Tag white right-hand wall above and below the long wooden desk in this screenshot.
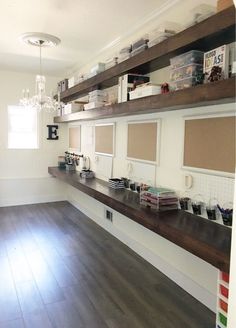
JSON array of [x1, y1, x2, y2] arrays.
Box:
[[68, 104, 234, 310]]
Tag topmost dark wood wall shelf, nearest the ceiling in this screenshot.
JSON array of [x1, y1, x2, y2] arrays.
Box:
[[61, 6, 235, 102]]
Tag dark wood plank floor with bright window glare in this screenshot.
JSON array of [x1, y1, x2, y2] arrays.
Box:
[[0, 202, 215, 328]]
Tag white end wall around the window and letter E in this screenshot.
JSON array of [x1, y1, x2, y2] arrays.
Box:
[[0, 71, 67, 206]]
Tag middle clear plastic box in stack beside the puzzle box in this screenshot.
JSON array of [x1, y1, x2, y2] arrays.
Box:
[[170, 64, 203, 82]]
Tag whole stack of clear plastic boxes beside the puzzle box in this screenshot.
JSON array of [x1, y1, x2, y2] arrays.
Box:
[[170, 50, 204, 89]]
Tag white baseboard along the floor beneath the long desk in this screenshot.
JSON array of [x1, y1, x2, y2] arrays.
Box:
[[68, 195, 216, 312]]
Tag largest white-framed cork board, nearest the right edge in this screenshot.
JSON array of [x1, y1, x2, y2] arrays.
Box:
[[183, 116, 235, 173]]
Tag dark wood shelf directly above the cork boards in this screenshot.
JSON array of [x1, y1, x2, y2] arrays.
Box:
[[54, 78, 235, 123]]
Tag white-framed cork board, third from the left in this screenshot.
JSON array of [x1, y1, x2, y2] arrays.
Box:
[[127, 122, 157, 162]]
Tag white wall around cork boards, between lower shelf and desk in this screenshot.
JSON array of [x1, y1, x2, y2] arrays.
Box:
[[73, 104, 234, 215]]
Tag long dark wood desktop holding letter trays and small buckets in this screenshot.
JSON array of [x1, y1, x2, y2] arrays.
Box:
[[48, 167, 231, 272]]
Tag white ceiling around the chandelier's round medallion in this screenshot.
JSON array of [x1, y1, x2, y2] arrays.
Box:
[[0, 0, 170, 76]]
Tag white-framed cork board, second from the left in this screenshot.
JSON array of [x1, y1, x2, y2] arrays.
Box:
[[95, 124, 114, 155]]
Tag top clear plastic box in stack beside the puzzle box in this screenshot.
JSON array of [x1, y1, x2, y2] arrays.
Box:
[[170, 50, 204, 69]]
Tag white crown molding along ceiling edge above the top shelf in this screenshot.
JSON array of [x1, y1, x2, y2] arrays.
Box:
[[70, 0, 181, 73]]
